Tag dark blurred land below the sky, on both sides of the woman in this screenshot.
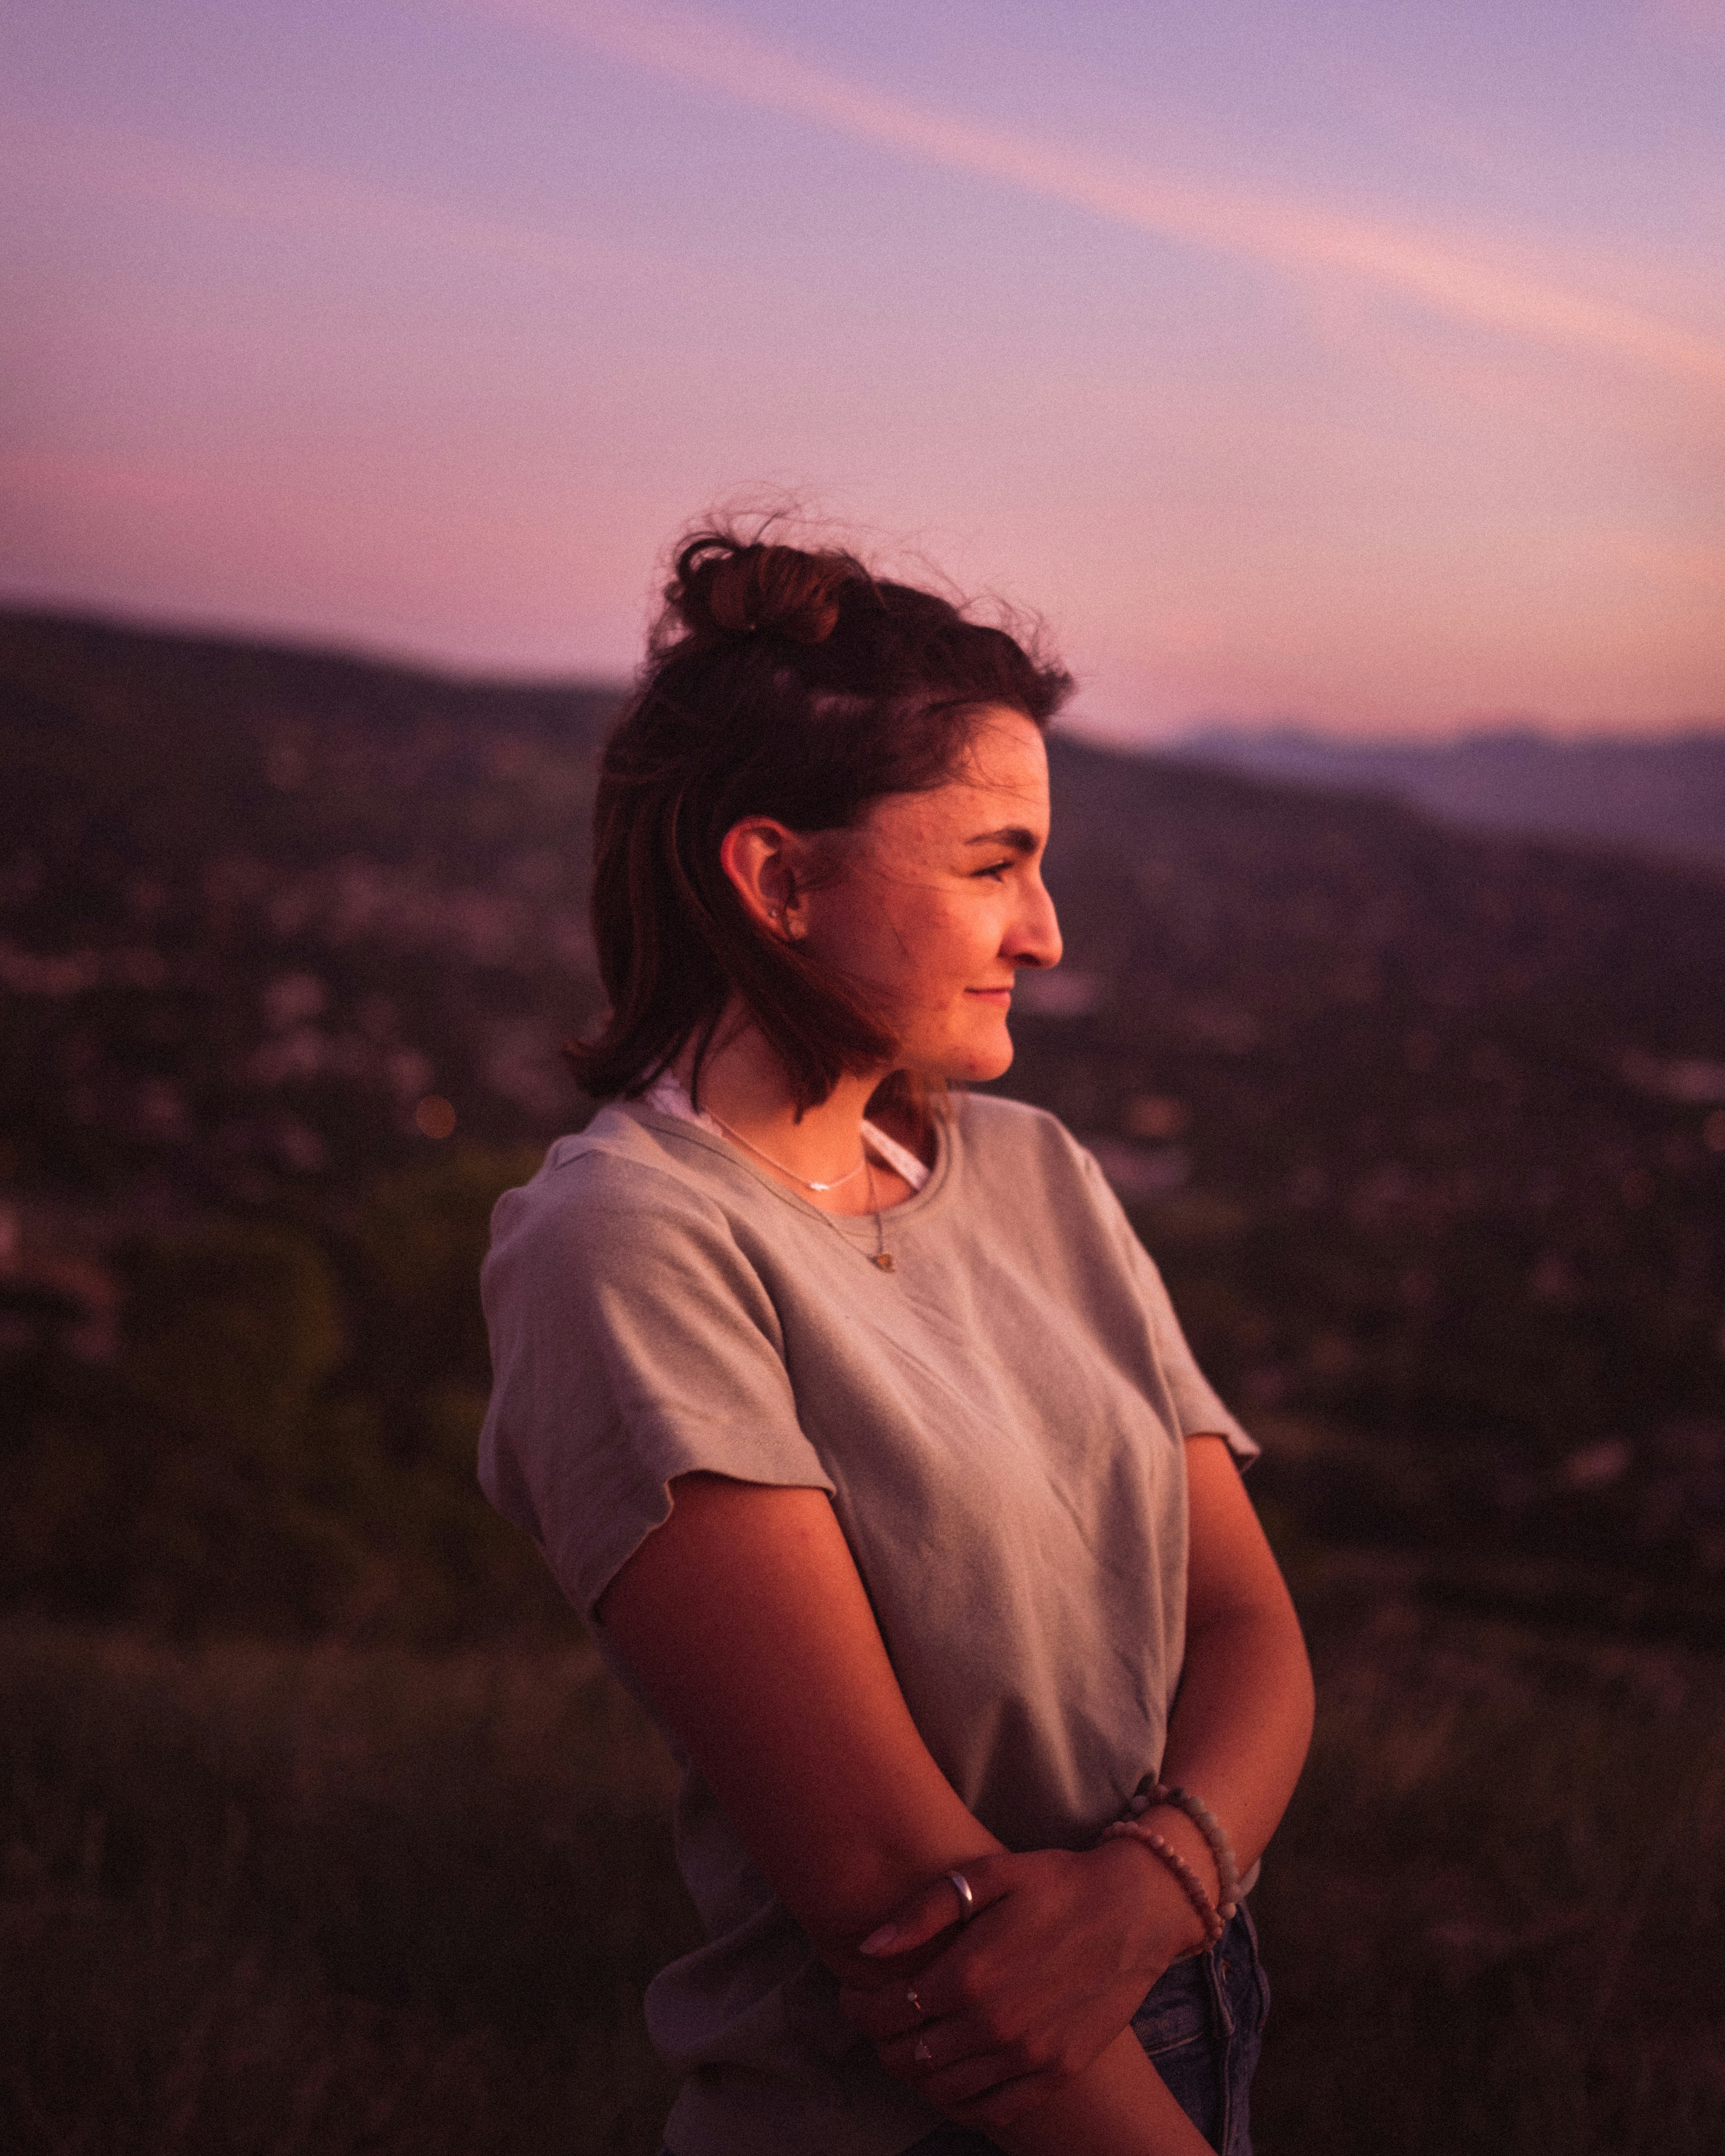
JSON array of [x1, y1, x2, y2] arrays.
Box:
[[0, 612, 1725, 2156]]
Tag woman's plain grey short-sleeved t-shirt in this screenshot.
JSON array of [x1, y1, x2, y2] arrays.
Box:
[[479, 1095, 1257, 2156]]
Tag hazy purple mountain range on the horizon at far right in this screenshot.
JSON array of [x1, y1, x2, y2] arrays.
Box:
[[1177, 720, 1725, 862]]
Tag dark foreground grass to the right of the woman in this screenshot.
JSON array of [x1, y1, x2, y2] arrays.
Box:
[[1255, 1574, 1725, 2156]]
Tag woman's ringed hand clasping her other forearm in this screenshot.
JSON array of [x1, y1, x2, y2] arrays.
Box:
[[839, 1841, 1203, 2126]]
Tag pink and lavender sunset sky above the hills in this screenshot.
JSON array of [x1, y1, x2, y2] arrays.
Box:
[[0, 0, 1725, 740]]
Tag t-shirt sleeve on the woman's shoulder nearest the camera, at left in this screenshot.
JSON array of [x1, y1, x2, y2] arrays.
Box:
[[479, 1147, 832, 1619]]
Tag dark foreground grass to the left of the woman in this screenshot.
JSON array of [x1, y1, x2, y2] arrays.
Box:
[[0, 1628, 694, 2156]]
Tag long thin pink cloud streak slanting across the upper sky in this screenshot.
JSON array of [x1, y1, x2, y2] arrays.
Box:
[[472, 0, 1725, 388]]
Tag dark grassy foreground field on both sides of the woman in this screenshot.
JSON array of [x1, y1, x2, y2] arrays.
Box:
[[0, 1567, 1725, 2156]]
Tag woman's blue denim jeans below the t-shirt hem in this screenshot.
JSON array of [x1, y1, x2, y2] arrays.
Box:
[[664, 1901, 1270, 2156]]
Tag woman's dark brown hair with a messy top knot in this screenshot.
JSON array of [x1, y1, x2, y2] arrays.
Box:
[[565, 530, 1071, 1112]]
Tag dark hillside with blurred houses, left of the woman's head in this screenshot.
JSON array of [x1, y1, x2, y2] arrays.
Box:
[[0, 614, 619, 1203]]
